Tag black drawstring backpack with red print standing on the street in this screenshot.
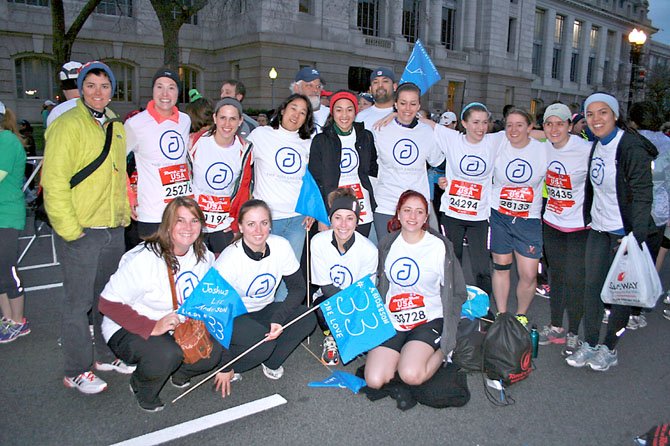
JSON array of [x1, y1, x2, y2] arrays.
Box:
[[482, 313, 533, 387]]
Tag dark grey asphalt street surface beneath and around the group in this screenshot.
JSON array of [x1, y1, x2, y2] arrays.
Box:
[[0, 217, 670, 445]]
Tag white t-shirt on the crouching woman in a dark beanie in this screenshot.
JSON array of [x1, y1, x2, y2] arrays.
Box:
[[310, 229, 379, 289]]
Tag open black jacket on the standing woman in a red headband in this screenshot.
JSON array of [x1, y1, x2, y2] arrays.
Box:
[[308, 122, 377, 212]]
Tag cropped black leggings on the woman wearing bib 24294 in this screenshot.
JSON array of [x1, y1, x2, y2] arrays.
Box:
[[440, 212, 493, 296]]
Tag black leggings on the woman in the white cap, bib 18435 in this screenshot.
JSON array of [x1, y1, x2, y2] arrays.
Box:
[[542, 223, 589, 334]]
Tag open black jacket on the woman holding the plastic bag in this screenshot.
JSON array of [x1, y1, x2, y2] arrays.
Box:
[[584, 131, 658, 243]]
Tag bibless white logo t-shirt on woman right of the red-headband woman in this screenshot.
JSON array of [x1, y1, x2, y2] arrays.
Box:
[[373, 120, 444, 215]]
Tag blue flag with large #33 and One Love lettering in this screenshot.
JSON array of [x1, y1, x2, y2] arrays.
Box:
[[319, 276, 396, 363]]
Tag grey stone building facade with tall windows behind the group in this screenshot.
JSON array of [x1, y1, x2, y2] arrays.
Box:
[[0, 0, 667, 120]]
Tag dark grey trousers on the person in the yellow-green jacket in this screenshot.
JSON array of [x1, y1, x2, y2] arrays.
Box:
[[54, 228, 125, 377]]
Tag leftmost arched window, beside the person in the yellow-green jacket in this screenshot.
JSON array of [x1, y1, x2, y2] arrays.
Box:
[[14, 56, 58, 100]]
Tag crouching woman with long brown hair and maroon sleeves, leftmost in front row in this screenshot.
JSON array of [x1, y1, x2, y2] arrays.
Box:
[[100, 197, 233, 412]]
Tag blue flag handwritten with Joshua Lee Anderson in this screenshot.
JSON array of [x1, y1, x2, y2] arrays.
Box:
[[177, 268, 247, 348]]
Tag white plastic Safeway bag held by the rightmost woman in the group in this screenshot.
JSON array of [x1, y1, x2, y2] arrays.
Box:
[[600, 232, 663, 308]]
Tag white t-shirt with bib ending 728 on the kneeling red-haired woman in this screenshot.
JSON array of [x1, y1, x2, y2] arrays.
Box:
[[384, 232, 446, 331]]
